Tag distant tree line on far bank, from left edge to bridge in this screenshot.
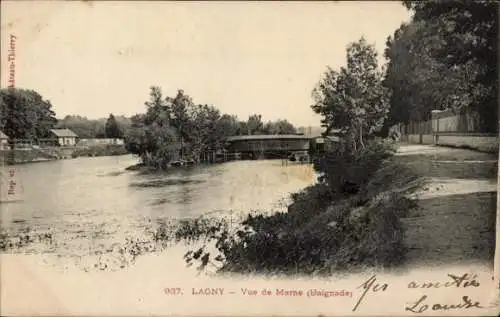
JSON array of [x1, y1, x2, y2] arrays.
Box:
[[0, 87, 296, 167]]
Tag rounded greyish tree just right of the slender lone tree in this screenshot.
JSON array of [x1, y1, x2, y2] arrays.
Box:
[[384, 21, 476, 124]]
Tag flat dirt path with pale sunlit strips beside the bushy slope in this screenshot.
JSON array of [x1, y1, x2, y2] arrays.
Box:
[[398, 145, 498, 267]]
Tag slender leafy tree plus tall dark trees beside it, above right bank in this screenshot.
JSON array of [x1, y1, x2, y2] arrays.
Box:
[[311, 0, 498, 150]]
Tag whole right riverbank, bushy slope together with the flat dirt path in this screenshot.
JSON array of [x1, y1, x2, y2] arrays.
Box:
[[170, 141, 498, 275]]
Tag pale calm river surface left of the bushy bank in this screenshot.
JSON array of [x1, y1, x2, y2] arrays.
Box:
[[0, 156, 314, 270]]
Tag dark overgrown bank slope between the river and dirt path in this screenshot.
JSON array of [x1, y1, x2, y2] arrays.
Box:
[[172, 141, 423, 274]]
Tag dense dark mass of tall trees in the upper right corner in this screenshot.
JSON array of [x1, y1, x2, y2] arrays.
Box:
[[385, 0, 498, 132]]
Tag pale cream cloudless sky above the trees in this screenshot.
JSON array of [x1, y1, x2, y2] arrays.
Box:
[[1, 1, 410, 126]]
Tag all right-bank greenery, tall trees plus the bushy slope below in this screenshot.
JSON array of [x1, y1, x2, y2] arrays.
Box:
[[164, 0, 498, 273]]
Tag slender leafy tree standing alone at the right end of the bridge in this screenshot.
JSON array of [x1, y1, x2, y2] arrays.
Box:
[[311, 38, 389, 150]]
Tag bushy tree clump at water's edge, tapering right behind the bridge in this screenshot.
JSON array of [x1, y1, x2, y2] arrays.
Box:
[[125, 86, 296, 168]]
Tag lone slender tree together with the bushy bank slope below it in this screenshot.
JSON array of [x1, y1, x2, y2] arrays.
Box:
[[170, 38, 423, 275]]
